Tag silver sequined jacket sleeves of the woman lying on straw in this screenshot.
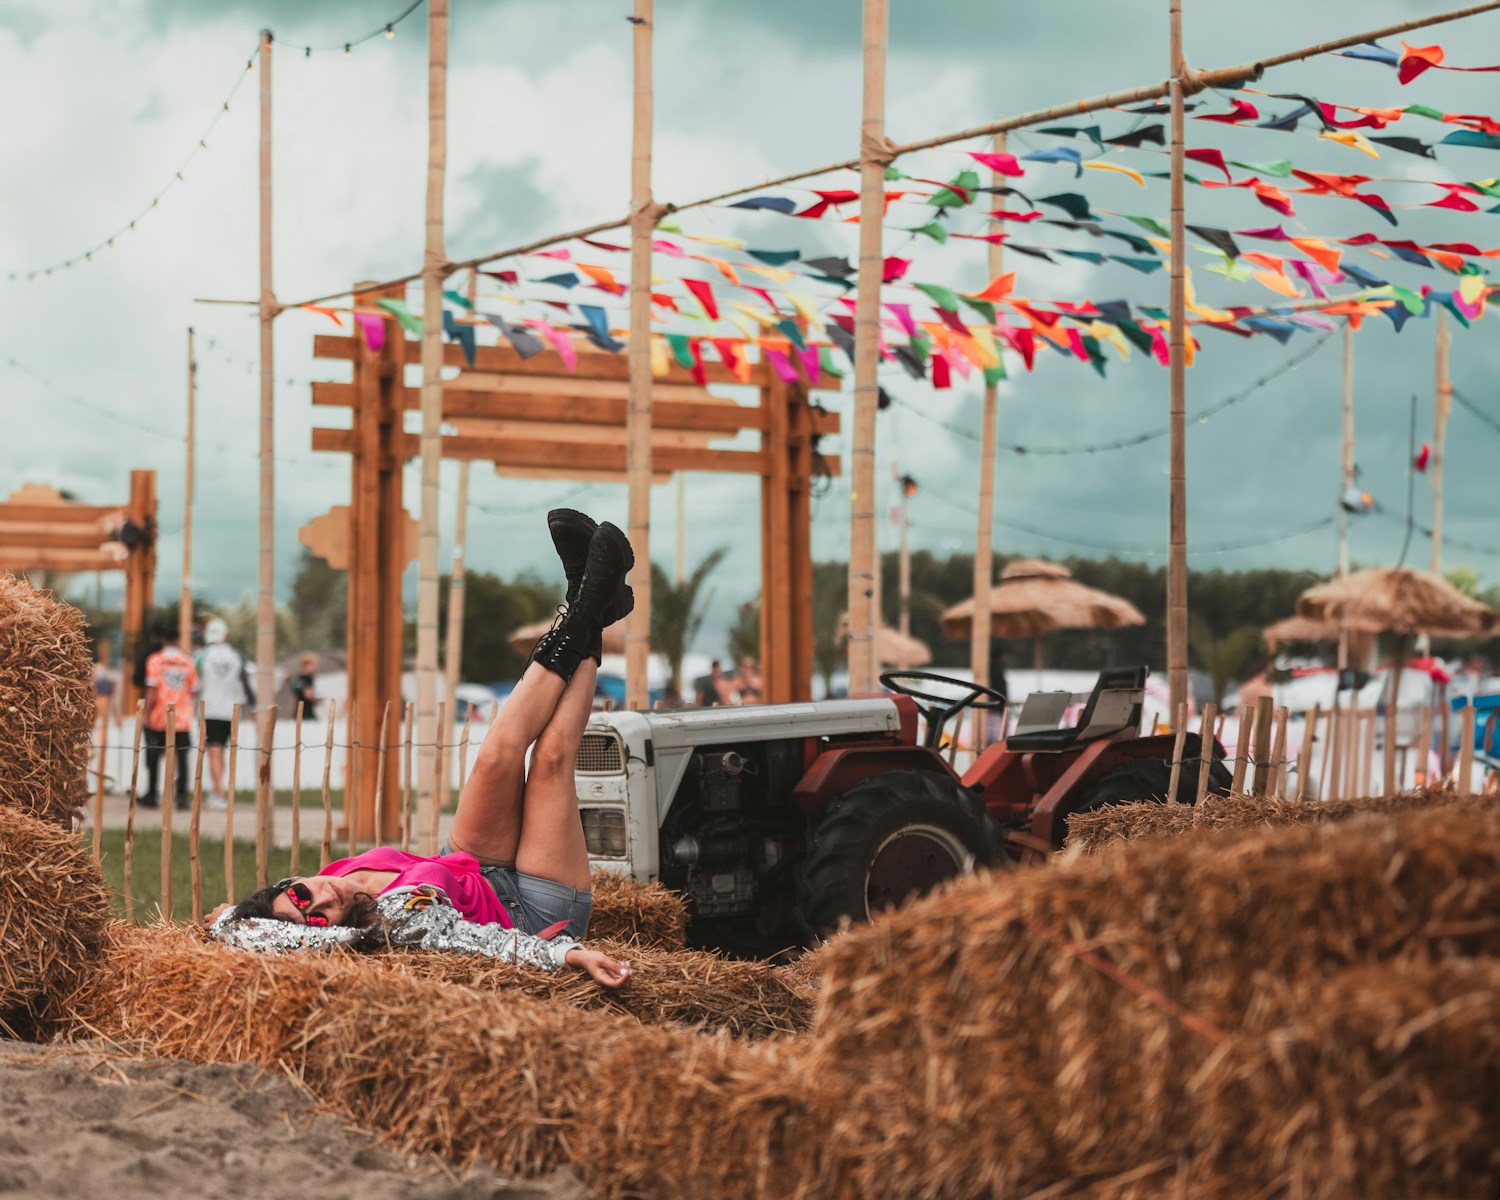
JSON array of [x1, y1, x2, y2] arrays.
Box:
[[210, 885, 578, 971]]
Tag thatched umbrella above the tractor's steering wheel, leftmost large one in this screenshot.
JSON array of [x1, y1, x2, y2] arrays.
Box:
[[942, 558, 1146, 681]]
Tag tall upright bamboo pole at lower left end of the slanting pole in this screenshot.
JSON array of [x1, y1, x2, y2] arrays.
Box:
[[255, 29, 278, 732]]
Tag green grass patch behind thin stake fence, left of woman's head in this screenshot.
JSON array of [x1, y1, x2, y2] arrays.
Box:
[[95, 828, 330, 926]]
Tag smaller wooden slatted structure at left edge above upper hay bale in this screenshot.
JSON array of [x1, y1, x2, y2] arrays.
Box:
[[0, 471, 156, 711]]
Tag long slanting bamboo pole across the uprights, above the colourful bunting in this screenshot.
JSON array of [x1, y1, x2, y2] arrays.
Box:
[[273, 0, 1500, 312]]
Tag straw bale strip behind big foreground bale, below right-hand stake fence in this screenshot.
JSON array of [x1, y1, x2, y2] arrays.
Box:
[[1068, 788, 1497, 854]]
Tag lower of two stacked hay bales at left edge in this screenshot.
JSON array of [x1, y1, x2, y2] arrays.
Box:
[[0, 807, 110, 1037]]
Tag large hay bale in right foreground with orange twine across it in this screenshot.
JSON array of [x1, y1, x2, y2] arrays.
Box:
[[810, 812, 1500, 1196]]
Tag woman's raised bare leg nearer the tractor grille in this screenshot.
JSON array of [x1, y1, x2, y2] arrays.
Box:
[[516, 660, 597, 891]]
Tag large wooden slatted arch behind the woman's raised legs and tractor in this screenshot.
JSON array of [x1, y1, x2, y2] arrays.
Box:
[[300, 291, 839, 840]]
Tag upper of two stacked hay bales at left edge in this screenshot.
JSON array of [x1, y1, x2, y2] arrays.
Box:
[[0, 573, 95, 828]]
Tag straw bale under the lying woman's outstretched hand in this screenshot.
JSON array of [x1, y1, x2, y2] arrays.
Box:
[[381, 938, 813, 1038]]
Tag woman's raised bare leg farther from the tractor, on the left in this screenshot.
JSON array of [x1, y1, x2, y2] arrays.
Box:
[[449, 660, 573, 866]]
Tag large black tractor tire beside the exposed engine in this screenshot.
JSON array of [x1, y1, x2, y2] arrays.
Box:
[[797, 771, 1010, 941]]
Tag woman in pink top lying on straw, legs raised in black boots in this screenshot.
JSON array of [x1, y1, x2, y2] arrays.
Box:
[[209, 509, 635, 987]]
